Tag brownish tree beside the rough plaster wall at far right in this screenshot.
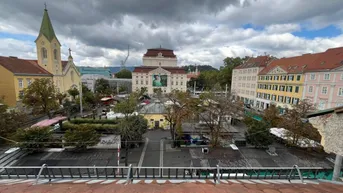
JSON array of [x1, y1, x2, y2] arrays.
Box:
[[279, 100, 321, 145]]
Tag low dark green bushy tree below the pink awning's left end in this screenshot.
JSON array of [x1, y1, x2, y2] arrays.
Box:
[[15, 127, 52, 151]]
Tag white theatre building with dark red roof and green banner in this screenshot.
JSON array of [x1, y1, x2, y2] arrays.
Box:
[[132, 48, 187, 94]]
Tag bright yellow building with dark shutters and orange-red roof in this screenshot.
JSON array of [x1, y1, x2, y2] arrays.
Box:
[[256, 54, 316, 109]]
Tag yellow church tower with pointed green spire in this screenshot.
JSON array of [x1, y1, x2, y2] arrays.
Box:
[[35, 7, 62, 76]]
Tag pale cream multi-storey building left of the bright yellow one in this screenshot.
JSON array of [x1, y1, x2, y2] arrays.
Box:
[[231, 56, 271, 106]]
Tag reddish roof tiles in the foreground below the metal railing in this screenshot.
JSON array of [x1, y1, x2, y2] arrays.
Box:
[[0, 180, 343, 193]]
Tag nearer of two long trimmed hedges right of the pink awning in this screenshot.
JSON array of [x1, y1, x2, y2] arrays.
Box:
[[62, 122, 119, 134]]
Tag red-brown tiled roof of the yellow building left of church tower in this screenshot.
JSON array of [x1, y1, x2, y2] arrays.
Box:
[[0, 56, 52, 76]]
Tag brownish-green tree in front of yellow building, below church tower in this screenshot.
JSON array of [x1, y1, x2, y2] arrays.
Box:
[[22, 78, 58, 118]]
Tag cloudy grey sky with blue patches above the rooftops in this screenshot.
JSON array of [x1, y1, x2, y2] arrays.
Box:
[[0, 0, 343, 67]]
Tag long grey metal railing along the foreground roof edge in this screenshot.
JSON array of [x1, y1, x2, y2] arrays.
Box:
[[0, 164, 333, 184]]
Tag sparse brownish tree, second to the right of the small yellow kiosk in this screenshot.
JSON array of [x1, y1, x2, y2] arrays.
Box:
[[193, 92, 244, 147]]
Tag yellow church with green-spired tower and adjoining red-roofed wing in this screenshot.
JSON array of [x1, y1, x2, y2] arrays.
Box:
[[0, 9, 81, 107]]
